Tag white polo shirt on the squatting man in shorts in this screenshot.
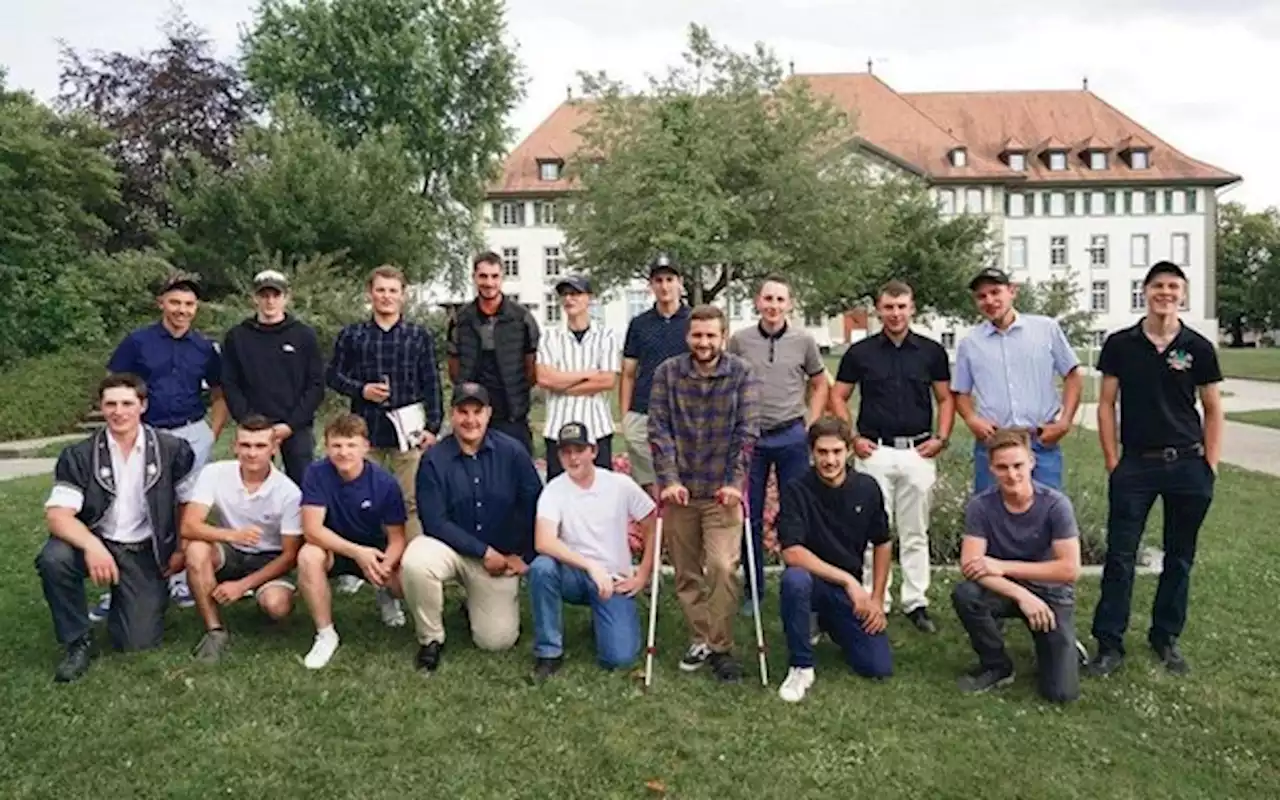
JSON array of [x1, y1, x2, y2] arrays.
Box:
[[191, 461, 302, 553]]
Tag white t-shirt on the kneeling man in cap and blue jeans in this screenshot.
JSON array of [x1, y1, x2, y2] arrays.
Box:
[[538, 470, 654, 575]]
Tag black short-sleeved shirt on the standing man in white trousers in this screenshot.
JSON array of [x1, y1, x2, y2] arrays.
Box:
[[836, 330, 951, 439]]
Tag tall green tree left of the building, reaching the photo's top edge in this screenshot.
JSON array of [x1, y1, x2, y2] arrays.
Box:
[[243, 0, 522, 280]]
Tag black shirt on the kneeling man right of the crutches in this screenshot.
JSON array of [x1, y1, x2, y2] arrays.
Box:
[[778, 467, 888, 580]]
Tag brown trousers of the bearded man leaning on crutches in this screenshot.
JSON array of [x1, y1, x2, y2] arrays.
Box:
[[663, 500, 742, 653]]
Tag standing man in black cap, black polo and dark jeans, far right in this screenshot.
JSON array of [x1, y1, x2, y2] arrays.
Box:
[[1089, 261, 1224, 677]]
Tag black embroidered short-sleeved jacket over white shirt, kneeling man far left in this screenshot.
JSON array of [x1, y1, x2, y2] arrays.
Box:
[[54, 425, 196, 570]]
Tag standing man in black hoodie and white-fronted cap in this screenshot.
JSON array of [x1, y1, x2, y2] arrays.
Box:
[[223, 270, 324, 486]]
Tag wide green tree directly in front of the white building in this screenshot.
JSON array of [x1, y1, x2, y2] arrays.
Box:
[[561, 26, 987, 312]]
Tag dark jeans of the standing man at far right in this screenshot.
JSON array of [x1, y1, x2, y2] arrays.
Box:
[[1093, 454, 1215, 653]]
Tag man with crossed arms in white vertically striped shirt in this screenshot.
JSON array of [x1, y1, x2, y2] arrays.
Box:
[[538, 275, 622, 480]]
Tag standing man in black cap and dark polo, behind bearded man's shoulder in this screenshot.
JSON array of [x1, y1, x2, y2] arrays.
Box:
[[618, 255, 690, 494]]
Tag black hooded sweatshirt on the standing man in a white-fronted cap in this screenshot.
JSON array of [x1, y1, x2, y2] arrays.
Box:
[[223, 315, 324, 430]]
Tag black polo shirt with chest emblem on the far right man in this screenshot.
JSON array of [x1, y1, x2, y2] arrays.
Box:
[[1098, 321, 1222, 451]]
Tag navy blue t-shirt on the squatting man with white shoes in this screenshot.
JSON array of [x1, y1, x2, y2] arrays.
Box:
[[302, 458, 408, 549]]
